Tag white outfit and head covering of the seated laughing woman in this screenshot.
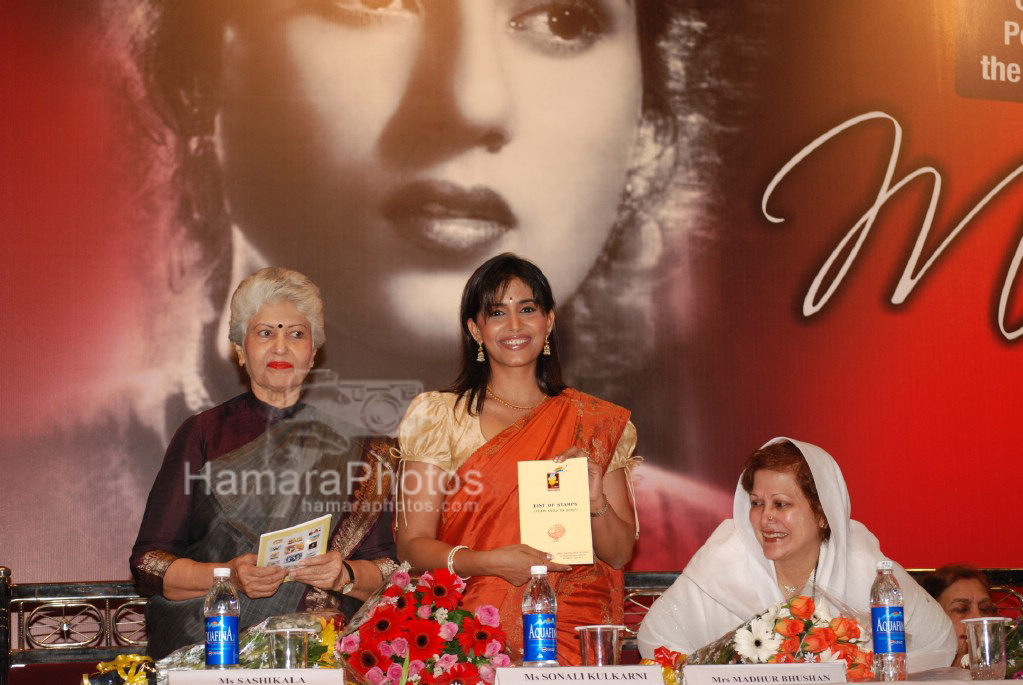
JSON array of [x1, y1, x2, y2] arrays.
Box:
[[638, 438, 957, 673]]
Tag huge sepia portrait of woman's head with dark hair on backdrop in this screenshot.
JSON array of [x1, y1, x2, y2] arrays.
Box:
[[138, 0, 724, 415]]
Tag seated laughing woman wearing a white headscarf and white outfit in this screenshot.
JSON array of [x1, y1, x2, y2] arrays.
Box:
[[638, 438, 955, 673]]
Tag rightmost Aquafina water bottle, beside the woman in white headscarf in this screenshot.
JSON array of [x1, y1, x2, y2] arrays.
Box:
[[871, 559, 905, 682]]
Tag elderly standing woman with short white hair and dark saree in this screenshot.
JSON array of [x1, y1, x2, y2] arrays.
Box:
[[131, 268, 395, 658]]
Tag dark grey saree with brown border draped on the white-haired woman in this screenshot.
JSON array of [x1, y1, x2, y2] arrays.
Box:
[[146, 407, 395, 658]]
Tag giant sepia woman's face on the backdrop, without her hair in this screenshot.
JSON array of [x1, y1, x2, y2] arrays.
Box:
[[218, 0, 641, 352]]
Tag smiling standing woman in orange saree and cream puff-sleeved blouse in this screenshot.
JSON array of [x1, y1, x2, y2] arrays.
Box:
[[396, 254, 638, 664]]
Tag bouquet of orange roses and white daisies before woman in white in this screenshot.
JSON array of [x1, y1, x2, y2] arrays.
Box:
[[655, 596, 874, 682]]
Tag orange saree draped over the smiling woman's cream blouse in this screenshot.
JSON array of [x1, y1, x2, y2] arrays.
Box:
[[438, 389, 629, 665]]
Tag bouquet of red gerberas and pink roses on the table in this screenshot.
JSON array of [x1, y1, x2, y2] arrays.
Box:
[[338, 564, 512, 685]]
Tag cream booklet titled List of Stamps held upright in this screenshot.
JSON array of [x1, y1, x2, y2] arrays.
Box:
[[519, 457, 593, 564]]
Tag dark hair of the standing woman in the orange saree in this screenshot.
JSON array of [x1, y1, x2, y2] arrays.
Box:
[[447, 253, 566, 414]]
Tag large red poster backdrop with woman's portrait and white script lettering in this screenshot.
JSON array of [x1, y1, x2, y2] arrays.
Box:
[[0, 0, 1023, 582]]
